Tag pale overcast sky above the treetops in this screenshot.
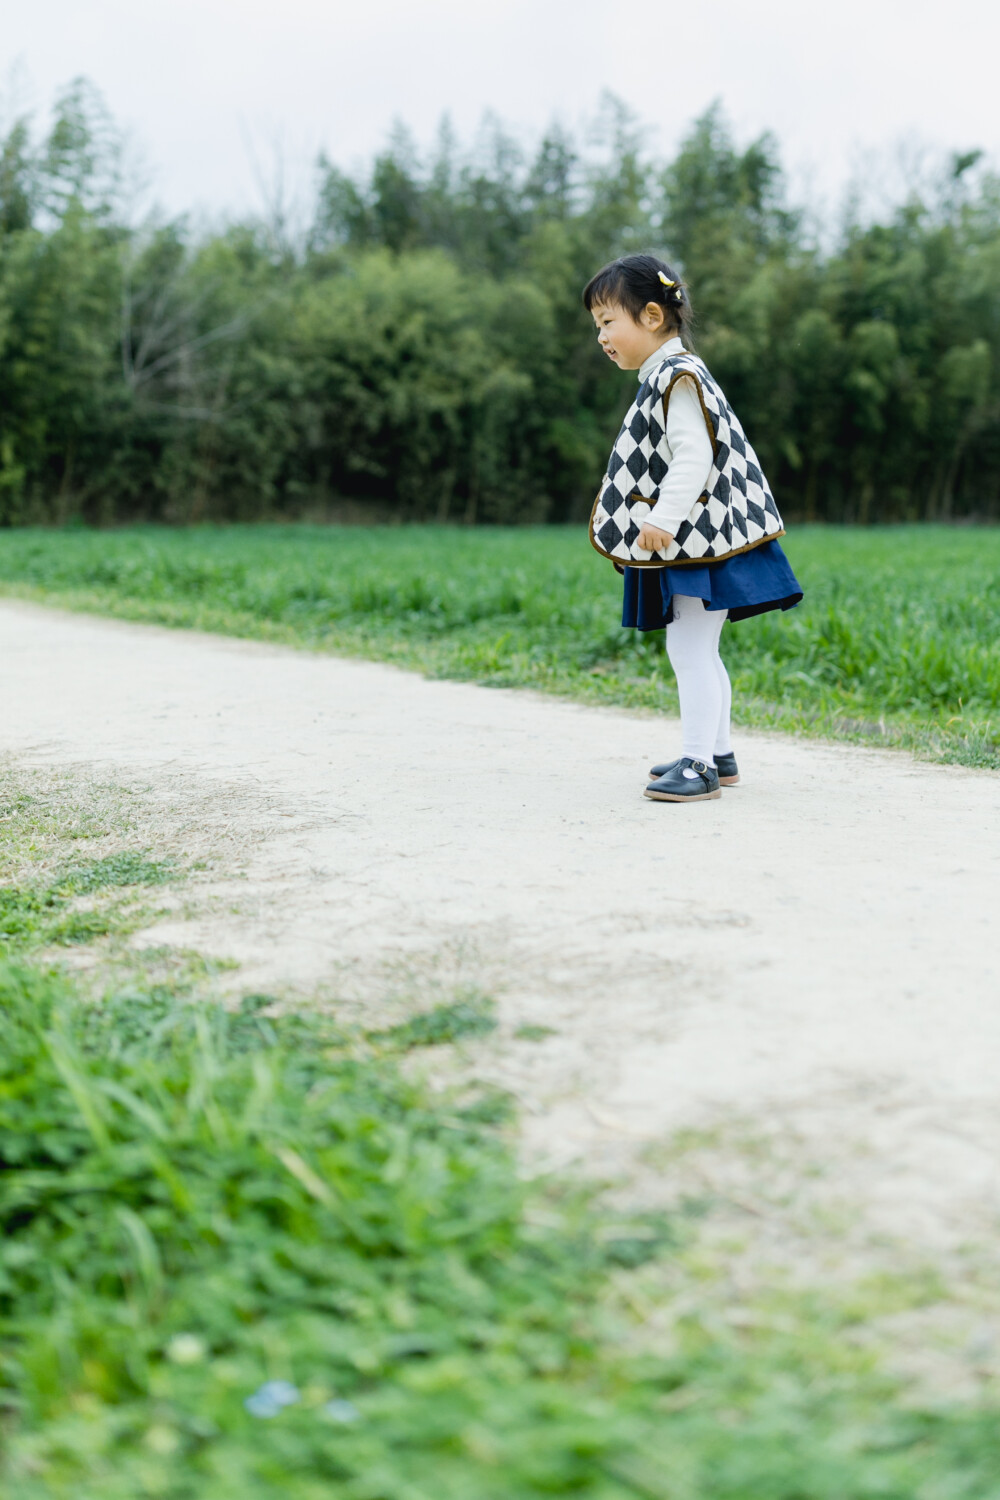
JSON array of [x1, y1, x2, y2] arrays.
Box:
[[0, 0, 1000, 225]]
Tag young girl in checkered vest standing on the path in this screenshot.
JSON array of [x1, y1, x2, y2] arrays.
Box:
[[583, 255, 802, 803]]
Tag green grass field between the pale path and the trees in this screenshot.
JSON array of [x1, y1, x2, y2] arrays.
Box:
[[0, 525, 1000, 767]]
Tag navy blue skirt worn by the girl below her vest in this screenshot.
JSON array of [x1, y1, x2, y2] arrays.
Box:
[[622, 542, 802, 630]]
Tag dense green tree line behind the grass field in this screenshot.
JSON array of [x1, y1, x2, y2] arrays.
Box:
[[0, 81, 1000, 525]]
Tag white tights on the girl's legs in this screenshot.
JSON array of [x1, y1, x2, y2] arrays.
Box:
[[667, 594, 733, 765]]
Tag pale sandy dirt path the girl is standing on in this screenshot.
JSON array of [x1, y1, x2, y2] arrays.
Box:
[[0, 600, 1000, 1266]]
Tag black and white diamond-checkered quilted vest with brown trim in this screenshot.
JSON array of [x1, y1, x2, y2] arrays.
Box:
[[591, 353, 784, 567]]
